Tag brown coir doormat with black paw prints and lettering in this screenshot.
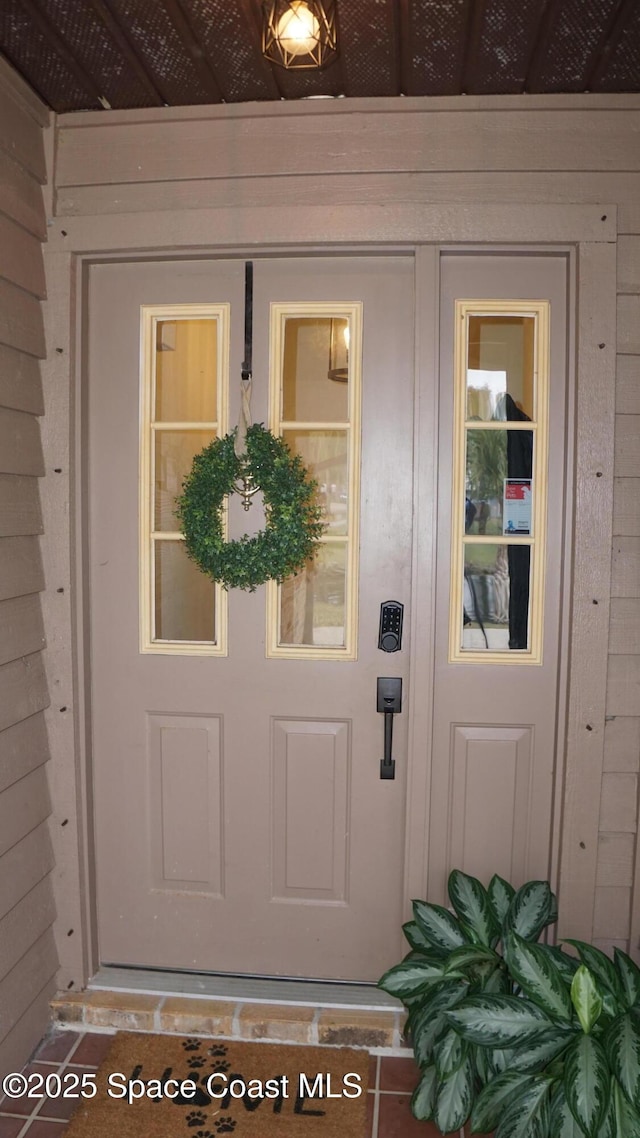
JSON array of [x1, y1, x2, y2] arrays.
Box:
[[64, 1032, 369, 1138]]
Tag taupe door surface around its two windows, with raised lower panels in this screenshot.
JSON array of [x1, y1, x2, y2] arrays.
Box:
[[89, 257, 413, 980]]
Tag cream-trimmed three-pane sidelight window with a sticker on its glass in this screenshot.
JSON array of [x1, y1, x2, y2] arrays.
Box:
[[450, 300, 549, 663]]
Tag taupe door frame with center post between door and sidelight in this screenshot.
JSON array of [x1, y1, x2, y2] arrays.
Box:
[[42, 203, 616, 990]]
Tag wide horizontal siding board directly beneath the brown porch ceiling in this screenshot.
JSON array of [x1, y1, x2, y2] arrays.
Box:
[[56, 105, 640, 187]]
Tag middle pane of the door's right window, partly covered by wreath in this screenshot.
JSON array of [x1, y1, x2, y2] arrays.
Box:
[[284, 430, 348, 535]]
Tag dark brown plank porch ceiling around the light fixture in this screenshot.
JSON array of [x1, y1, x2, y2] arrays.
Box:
[[0, 0, 640, 112]]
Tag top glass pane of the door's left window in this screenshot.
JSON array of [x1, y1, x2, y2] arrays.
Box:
[[155, 319, 218, 422]]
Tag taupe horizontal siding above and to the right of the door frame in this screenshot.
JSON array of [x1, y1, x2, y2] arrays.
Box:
[[48, 96, 640, 975]]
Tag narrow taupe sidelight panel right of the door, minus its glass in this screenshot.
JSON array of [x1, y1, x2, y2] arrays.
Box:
[[428, 254, 567, 900]]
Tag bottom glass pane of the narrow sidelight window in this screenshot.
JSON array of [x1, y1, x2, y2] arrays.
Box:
[[461, 544, 531, 652]]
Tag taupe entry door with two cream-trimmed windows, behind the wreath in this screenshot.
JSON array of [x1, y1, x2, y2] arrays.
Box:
[[88, 256, 413, 980]]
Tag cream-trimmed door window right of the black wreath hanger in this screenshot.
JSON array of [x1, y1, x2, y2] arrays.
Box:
[[268, 302, 362, 660]]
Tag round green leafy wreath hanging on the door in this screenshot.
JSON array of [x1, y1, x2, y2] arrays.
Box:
[[175, 423, 323, 593]]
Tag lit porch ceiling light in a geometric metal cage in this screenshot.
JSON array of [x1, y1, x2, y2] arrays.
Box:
[[262, 0, 337, 71]]
